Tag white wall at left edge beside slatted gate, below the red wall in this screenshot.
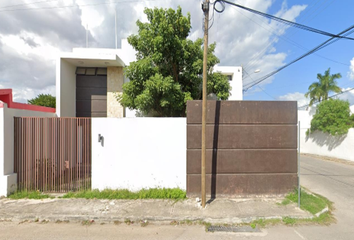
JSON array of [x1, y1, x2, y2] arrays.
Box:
[[0, 103, 56, 196]]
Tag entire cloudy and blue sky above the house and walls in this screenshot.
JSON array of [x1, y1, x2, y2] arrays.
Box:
[[0, 0, 354, 106]]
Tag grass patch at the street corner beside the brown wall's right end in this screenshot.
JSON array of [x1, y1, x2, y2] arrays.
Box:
[[282, 189, 332, 214]]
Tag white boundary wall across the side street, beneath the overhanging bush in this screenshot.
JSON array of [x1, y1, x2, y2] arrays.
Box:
[[298, 108, 354, 161]]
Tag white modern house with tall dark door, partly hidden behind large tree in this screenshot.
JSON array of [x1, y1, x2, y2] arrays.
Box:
[[56, 39, 243, 118]]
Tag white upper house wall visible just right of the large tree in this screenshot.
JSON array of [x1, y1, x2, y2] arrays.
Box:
[[214, 66, 243, 100]]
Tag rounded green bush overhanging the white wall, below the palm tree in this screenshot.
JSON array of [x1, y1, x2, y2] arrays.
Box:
[[310, 99, 354, 136]]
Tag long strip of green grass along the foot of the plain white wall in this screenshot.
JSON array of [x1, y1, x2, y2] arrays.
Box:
[[63, 188, 186, 200]]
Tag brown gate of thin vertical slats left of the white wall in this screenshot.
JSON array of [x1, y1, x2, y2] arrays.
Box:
[[14, 117, 91, 192]]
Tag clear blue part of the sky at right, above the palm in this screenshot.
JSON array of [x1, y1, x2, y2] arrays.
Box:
[[244, 0, 354, 104]]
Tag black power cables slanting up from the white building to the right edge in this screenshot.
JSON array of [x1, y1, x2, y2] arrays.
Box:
[[244, 25, 354, 91]]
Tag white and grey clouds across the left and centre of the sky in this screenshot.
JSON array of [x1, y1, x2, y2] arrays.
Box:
[[0, 0, 306, 100]]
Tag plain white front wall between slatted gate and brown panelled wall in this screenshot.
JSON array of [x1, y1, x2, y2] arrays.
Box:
[[92, 118, 186, 191]]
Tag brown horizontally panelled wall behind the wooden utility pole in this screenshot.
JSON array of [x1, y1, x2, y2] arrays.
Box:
[[187, 101, 297, 197]]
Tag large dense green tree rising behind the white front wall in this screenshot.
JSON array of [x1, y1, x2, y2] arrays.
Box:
[[117, 7, 231, 117]]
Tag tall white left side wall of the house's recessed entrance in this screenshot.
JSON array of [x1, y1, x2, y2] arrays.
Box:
[[56, 58, 76, 117]]
